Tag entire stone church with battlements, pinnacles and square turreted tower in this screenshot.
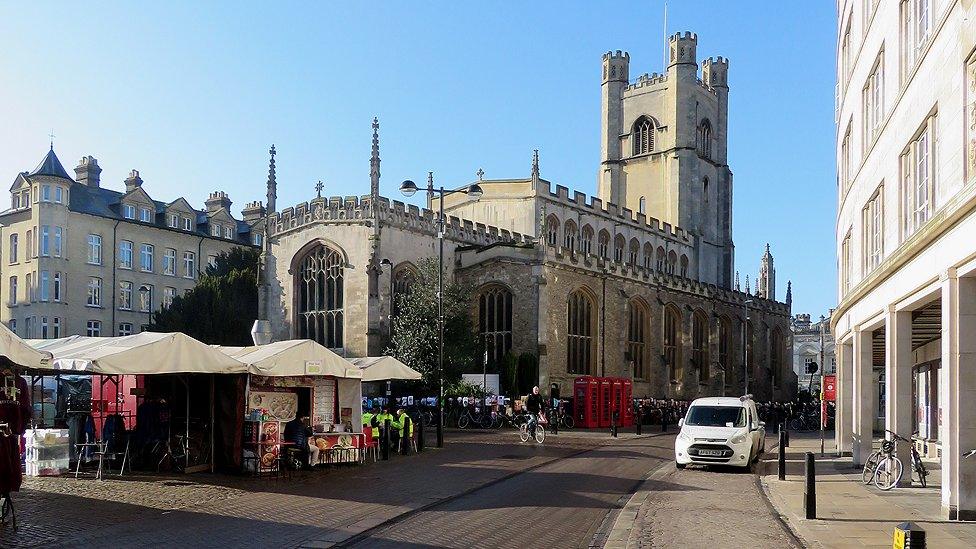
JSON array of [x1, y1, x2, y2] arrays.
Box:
[[261, 33, 796, 399]]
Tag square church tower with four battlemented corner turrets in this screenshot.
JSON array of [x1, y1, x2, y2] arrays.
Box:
[[597, 32, 735, 288]]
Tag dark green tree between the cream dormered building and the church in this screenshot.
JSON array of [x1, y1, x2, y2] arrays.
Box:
[[150, 247, 261, 345]]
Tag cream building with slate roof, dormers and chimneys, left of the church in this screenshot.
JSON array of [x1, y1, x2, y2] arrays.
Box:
[[0, 145, 265, 338]]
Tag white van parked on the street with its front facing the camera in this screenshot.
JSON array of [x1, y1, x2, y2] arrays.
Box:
[[674, 395, 766, 469]]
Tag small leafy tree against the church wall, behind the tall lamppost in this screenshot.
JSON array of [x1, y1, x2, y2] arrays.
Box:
[[387, 258, 481, 388]]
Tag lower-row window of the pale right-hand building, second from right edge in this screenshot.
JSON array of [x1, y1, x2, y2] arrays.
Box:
[[901, 116, 935, 239]]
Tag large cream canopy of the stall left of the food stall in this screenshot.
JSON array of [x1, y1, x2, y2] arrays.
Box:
[[27, 332, 247, 375]]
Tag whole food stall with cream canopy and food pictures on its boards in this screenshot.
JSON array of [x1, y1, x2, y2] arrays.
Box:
[[217, 339, 363, 473]]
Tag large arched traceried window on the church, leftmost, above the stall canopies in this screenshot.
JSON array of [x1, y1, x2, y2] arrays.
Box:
[[296, 245, 343, 349]]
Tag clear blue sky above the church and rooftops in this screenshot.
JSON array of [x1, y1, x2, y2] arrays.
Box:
[[0, 0, 836, 316]]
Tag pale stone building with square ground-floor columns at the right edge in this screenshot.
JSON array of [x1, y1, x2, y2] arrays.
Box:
[[831, 0, 976, 520]]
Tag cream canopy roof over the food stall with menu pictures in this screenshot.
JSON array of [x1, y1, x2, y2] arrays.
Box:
[[215, 339, 362, 379]]
